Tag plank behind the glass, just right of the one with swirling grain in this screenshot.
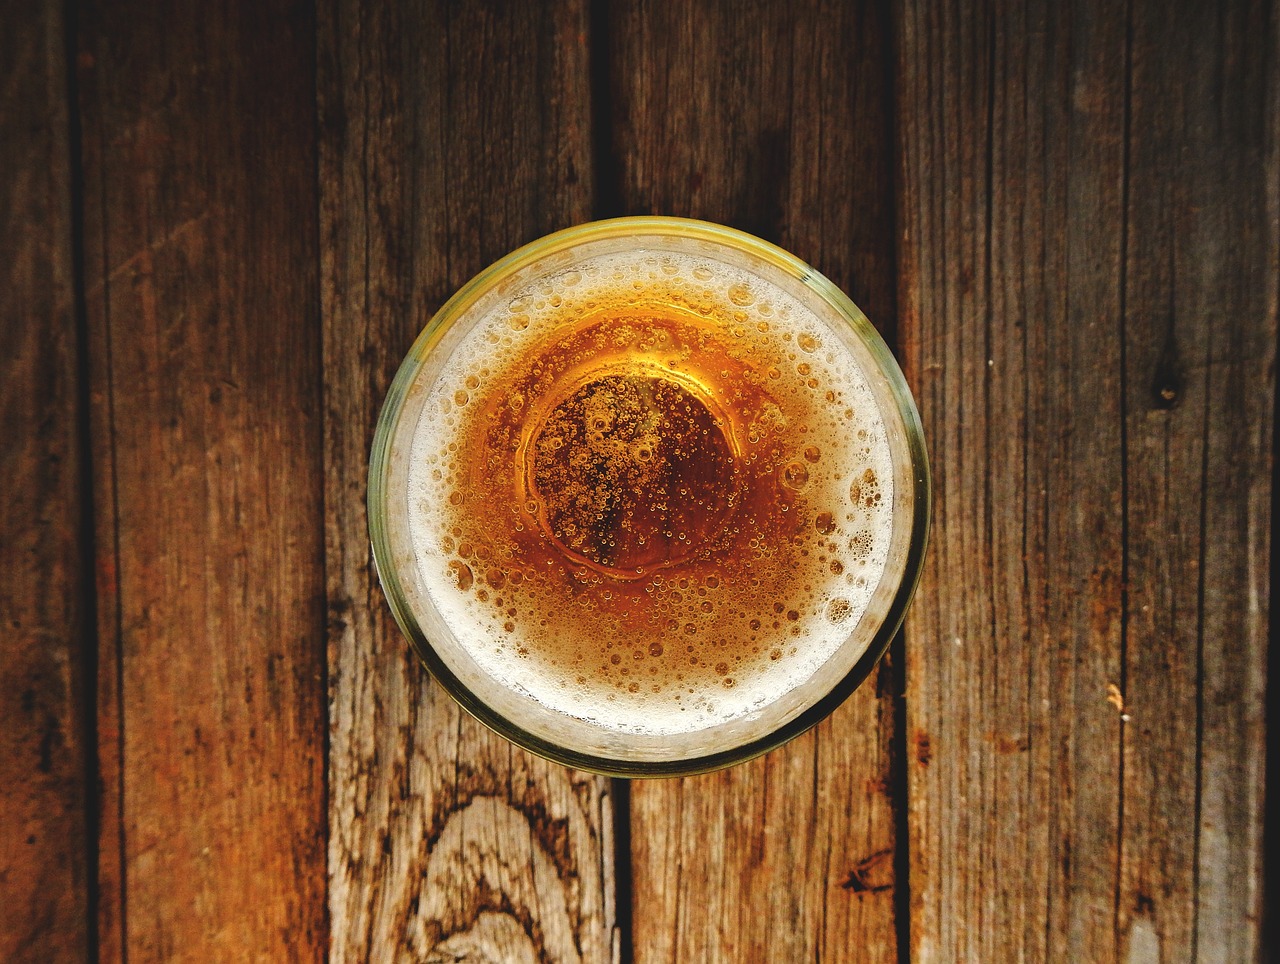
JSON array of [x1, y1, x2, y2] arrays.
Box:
[[602, 3, 897, 961]]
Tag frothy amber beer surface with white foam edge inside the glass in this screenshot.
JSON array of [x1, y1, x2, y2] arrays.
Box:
[[408, 250, 893, 735]]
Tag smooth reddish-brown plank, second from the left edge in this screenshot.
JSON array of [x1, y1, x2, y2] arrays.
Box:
[[77, 3, 328, 960]]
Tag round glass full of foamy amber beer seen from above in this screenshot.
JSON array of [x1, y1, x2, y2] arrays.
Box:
[[369, 218, 931, 777]]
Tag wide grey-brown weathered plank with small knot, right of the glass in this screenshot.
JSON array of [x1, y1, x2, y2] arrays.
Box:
[[896, 3, 1277, 961]]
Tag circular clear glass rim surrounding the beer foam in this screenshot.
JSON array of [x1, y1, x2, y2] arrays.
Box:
[[366, 215, 933, 778]]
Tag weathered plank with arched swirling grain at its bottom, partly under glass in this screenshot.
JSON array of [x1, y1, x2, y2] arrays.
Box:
[[319, 0, 620, 961]]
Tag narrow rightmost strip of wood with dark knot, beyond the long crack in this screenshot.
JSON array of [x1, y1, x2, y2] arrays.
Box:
[[1117, 1, 1280, 961]]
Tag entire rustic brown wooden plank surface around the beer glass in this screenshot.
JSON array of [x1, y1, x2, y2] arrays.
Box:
[[0, 0, 1280, 961]]
